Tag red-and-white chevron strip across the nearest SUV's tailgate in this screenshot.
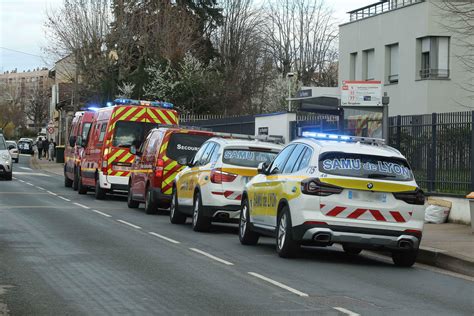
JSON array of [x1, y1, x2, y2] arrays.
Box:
[[320, 204, 413, 223]]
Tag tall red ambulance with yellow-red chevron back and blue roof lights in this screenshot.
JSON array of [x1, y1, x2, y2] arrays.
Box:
[[76, 99, 178, 199]]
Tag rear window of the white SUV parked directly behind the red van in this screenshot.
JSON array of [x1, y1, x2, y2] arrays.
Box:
[[222, 148, 277, 168]]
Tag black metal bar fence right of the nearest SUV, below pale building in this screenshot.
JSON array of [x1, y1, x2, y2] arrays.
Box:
[[389, 111, 474, 195]]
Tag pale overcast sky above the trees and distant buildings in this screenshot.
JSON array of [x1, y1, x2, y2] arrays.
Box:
[[0, 0, 377, 73]]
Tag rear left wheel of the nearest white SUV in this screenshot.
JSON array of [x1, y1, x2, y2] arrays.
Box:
[[276, 206, 299, 258]]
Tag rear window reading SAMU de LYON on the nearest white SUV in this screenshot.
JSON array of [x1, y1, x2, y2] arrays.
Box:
[[319, 152, 413, 181]]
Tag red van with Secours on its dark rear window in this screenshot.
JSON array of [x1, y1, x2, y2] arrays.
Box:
[[127, 127, 214, 214]]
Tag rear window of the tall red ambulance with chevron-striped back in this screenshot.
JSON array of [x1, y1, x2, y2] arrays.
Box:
[[112, 121, 158, 148]]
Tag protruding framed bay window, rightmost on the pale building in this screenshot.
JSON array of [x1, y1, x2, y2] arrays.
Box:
[[417, 36, 449, 79]]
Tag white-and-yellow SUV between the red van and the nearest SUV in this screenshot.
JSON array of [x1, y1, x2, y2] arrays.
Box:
[[170, 138, 282, 231]]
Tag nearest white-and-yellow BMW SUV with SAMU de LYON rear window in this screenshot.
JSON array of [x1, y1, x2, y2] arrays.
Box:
[[239, 133, 425, 266]]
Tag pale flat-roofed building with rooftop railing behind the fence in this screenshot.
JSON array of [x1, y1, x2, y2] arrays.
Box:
[[339, 0, 474, 116]]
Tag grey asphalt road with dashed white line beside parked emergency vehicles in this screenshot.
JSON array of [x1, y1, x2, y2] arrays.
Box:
[[0, 156, 474, 315]]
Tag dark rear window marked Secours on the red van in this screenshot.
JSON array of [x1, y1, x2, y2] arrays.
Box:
[[166, 133, 212, 161]]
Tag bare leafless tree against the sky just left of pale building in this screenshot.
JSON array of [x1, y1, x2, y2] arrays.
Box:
[[265, 0, 337, 85]]
